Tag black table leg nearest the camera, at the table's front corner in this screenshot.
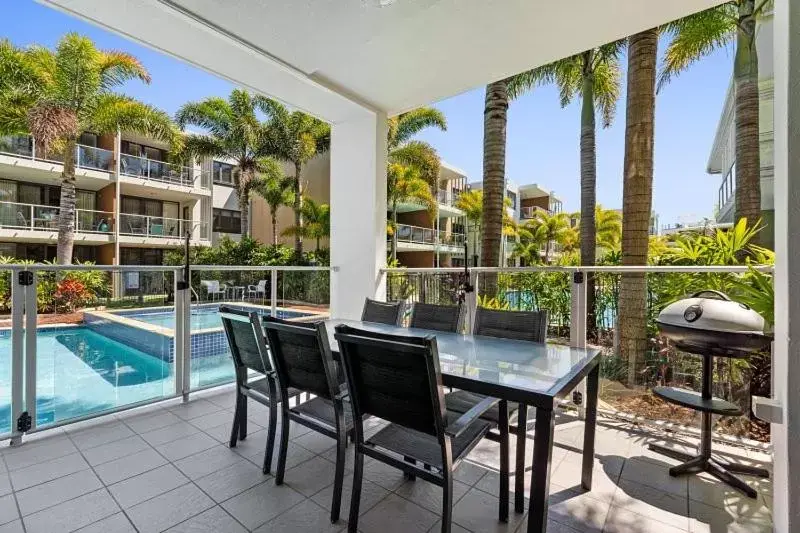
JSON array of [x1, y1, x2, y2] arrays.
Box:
[[528, 407, 555, 533]]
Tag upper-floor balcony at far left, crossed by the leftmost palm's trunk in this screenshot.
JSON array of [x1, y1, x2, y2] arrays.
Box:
[[0, 135, 114, 189]]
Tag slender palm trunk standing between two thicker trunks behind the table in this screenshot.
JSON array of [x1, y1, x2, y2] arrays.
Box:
[[579, 50, 597, 339]]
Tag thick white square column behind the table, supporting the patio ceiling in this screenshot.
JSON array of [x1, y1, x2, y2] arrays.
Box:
[[330, 110, 387, 318]]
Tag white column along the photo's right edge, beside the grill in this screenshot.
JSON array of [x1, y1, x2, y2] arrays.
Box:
[[772, 0, 800, 531]]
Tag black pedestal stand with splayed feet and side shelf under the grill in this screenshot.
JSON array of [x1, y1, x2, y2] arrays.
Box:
[[649, 354, 769, 498]]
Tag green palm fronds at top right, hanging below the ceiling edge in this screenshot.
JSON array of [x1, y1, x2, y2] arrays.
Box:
[[656, 3, 736, 91]]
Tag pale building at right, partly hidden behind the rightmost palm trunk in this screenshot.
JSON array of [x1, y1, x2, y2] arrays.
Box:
[[706, 13, 775, 248]]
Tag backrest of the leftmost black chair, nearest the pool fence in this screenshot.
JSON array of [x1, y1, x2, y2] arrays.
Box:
[[219, 305, 272, 374]]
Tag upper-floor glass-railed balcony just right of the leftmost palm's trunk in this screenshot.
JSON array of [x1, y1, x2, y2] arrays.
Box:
[[119, 154, 211, 201]]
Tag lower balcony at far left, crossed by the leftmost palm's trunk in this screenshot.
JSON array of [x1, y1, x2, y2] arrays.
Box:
[[0, 202, 114, 244]]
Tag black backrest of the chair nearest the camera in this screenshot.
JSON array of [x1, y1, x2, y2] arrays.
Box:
[[336, 325, 446, 440]]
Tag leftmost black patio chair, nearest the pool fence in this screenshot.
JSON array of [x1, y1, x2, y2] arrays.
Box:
[[219, 305, 300, 474]]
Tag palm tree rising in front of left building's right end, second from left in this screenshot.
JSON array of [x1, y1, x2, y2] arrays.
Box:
[[175, 89, 283, 236]]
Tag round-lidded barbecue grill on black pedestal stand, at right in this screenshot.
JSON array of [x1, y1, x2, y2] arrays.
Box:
[[650, 290, 772, 498]]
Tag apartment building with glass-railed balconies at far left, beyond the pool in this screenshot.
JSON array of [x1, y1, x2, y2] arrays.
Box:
[[0, 132, 212, 265]]
